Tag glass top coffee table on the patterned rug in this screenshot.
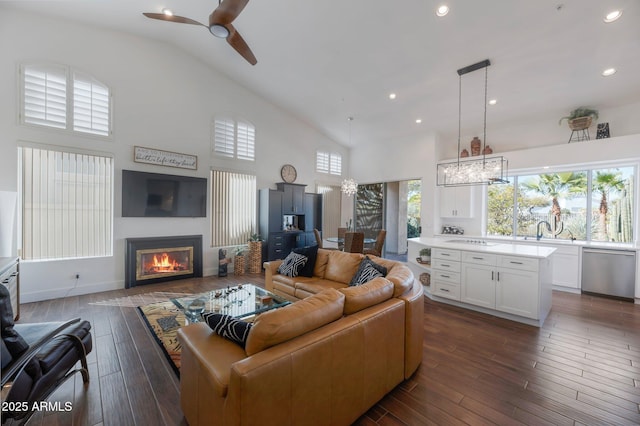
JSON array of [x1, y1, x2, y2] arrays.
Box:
[[171, 284, 291, 322]]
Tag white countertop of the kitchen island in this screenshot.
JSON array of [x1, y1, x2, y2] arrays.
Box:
[[409, 236, 556, 259]]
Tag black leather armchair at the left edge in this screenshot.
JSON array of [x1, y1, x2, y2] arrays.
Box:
[[0, 285, 92, 424]]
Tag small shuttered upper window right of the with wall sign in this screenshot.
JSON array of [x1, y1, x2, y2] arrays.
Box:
[[211, 117, 256, 161]]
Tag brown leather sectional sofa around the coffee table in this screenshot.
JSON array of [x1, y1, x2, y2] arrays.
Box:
[[178, 249, 424, 426]]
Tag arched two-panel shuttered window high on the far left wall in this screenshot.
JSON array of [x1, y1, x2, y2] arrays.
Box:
[[21, 65, 111, 136]]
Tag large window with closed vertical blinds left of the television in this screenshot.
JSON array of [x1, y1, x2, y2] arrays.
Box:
[[18, 147, 113, 260]]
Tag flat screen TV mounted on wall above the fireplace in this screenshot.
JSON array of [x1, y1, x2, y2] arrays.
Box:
[[122, 170, 207, 217]]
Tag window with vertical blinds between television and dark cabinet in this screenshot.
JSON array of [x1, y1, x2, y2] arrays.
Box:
[[211, 170, 257, 247]]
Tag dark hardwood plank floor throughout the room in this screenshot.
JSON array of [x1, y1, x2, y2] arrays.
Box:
[[13, 275, 640, 426]]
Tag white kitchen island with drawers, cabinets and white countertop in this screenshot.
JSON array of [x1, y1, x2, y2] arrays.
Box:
[[407, 237, 556, 327]]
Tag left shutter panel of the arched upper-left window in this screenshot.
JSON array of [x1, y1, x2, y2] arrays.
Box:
[[22, 65, 67, 129]]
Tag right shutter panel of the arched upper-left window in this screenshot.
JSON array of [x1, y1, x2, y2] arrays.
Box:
[[73, 73, 110, 136]]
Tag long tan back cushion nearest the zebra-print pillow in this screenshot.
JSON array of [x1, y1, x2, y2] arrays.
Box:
[[245, 289, 345, 356]]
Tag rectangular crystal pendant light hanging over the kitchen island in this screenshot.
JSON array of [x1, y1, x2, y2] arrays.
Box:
[[436, 59, 509, 186]]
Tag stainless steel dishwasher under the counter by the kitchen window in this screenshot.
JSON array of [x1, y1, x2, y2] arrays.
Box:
[[582, 248, 636, 300]]
